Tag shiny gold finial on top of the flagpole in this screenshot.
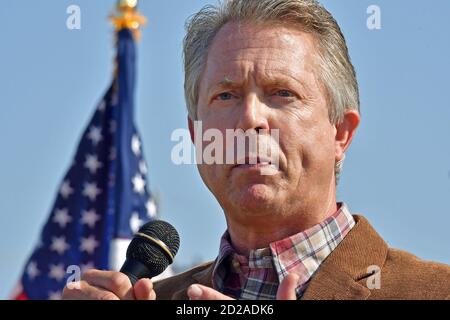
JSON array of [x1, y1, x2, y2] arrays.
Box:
[[110, 0, 147, 40]]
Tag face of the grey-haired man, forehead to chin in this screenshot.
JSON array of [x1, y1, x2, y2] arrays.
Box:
[[192, 23, 342, 219]]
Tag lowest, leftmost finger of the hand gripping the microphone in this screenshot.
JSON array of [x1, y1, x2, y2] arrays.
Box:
[[62, 280, 119, 300]]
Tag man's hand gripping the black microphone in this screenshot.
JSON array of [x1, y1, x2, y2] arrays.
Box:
[[62, 269, 156, 300]]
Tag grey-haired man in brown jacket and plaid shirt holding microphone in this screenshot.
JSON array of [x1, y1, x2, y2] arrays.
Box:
[[64, 0, 450, 299]]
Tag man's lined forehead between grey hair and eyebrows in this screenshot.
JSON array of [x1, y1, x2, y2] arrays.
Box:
[[203, 23, 316, 82]]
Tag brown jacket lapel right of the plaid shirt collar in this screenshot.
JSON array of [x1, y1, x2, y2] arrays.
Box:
[[302, 216, 388, 300]]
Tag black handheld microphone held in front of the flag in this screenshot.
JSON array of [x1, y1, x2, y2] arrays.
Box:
[[120, 220, 180, 285]]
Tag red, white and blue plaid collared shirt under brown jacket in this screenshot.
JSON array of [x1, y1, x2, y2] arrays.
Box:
[[213, 203, 355, 300]]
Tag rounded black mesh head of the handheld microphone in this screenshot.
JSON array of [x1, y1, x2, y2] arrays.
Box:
[[127, 220, 180, 277]]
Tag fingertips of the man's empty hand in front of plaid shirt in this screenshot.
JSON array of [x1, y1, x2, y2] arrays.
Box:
[[187, 273, 299, 300]]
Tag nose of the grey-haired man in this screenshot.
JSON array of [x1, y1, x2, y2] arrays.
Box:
[[236, 94, 269, 132]]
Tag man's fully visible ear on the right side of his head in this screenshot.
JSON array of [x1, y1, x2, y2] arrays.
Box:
[[335, 110, 361, 162]]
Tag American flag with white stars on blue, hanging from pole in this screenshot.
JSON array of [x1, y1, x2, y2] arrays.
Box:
[[15, 29, 156, 299]]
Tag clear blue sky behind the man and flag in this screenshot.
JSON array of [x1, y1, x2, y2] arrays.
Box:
[[0, 0, 450, 298]]
